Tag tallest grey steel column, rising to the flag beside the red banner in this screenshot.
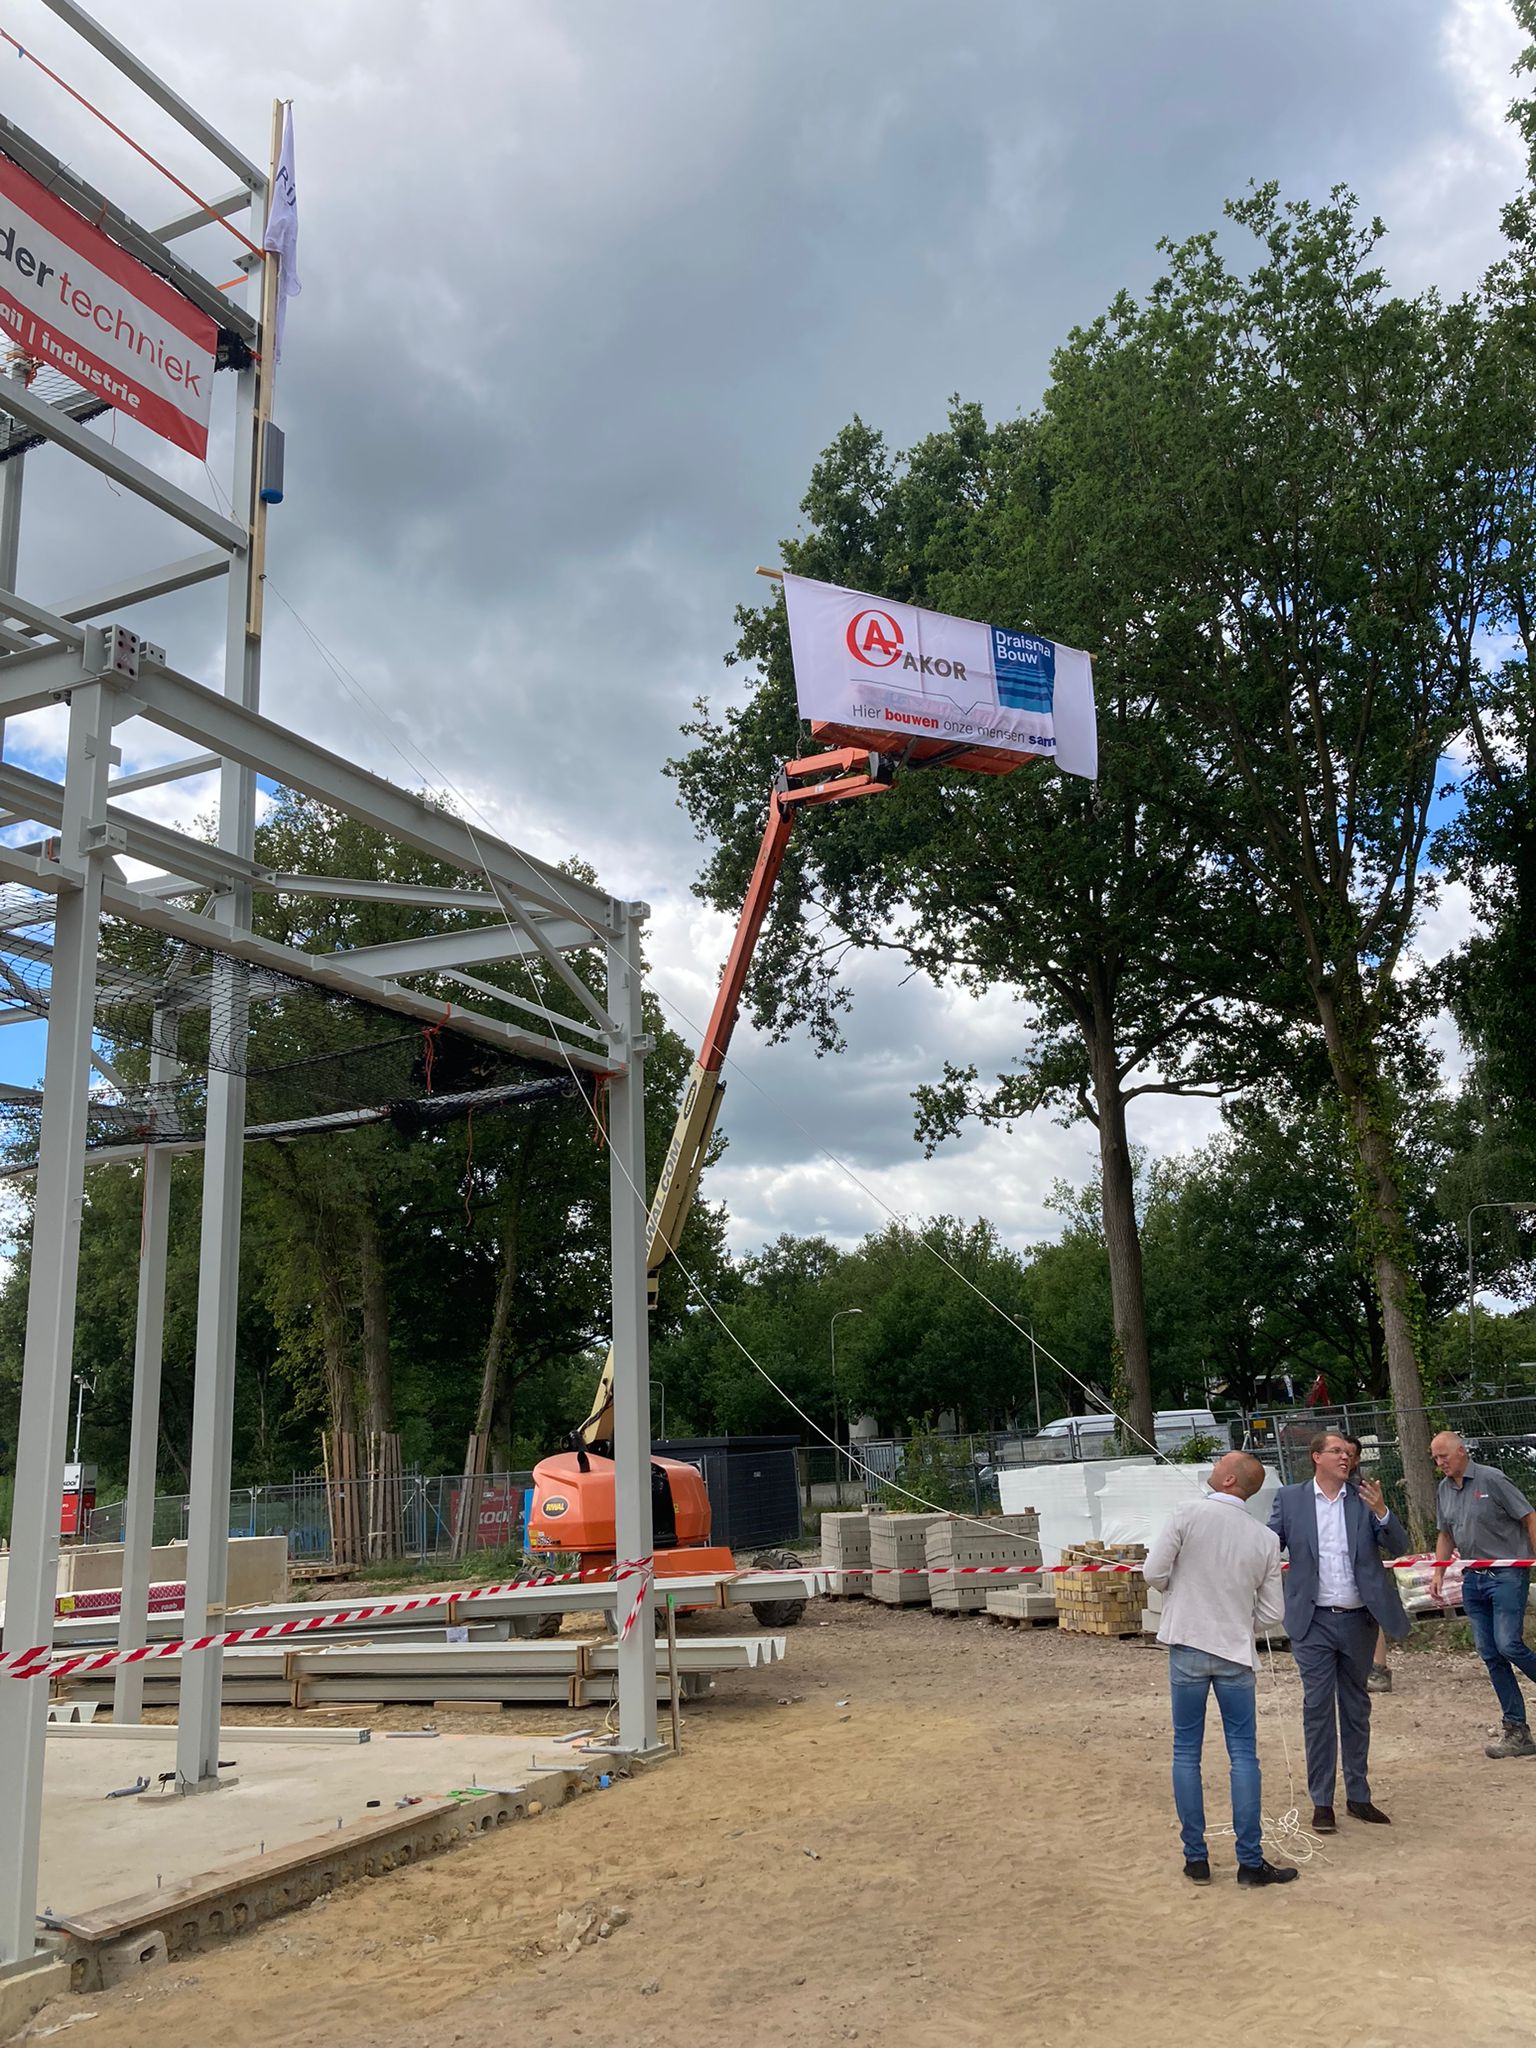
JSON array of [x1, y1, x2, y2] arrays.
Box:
[[176, 335, 260, 1792]]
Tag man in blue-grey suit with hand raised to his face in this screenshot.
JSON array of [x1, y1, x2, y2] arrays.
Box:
[[1270, 1432, 1411, 1835]]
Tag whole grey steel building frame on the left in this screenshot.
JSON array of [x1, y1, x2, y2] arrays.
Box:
[[0, 0, 655, 1968]]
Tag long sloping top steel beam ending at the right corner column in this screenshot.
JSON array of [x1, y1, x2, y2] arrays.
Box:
[[133, 655, 612, 936]]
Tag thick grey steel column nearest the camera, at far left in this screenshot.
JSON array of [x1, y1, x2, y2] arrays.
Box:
[[0, 682, 113, 1964]]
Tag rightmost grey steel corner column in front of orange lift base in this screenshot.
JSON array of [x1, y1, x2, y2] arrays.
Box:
[[608, 903, 655, 1751]]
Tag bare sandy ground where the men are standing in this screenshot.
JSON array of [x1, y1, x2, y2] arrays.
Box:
[[15, 1602, 1536, 2048]]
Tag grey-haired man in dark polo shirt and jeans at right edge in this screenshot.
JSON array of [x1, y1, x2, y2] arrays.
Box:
[[1430, 1430, 1536, 1757]]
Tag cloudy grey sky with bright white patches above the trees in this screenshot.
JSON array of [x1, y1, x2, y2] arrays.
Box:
[[0, 0, 1520, 1249]]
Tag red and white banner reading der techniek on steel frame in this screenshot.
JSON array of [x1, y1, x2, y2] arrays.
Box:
[[0, 156, 219, 459]]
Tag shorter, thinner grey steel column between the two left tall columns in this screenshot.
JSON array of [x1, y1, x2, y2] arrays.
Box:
[[113, 1010, 180, 1726]]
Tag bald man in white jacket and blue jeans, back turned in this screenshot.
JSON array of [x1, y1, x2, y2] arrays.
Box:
[[1143, 1450, 1296, 1884]]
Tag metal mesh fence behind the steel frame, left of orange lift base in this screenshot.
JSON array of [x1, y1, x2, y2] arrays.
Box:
[[88, 1473, 532, 1565]]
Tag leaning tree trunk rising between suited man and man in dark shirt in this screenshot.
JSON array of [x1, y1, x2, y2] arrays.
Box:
[[1315, 969, 1436, 1550]]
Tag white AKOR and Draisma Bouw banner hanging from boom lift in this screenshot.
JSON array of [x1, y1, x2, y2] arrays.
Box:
[[784, 575, 1098, 778]]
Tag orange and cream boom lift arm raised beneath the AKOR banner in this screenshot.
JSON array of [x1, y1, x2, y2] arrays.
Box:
[[571, 748, 895, 1450]]
